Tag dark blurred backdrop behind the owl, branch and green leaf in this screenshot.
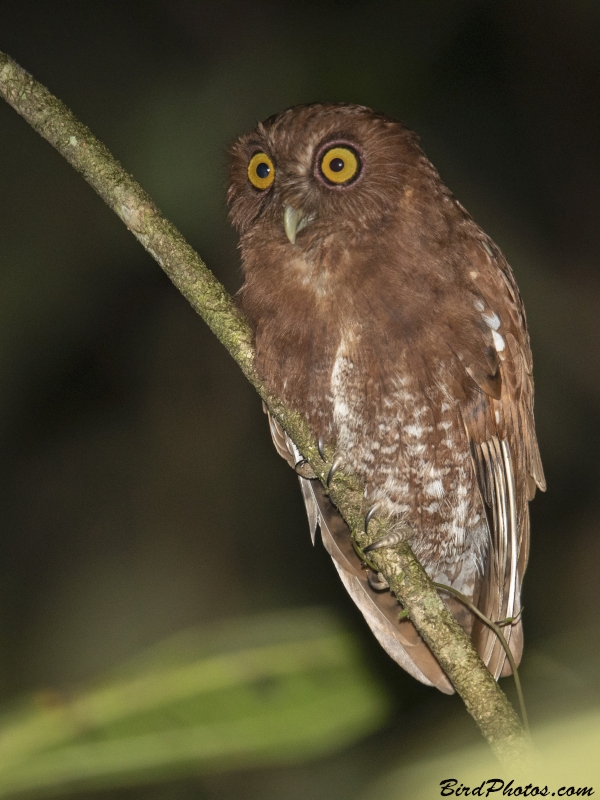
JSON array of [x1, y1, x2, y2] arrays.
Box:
[[0, 0, 600, 800]]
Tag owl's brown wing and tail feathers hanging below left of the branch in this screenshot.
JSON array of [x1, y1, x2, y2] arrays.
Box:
[[265, 409, 454, 694]]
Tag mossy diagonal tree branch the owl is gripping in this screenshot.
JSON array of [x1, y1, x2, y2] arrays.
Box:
[[0, 52, 530, 764]]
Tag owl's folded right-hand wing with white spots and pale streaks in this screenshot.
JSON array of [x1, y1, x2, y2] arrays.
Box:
[[451, 247, 545, 678]]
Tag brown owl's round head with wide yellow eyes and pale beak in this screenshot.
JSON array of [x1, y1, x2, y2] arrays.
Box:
[[227, 104, 428, 252]]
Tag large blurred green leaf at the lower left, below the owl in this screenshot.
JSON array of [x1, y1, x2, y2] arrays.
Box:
[[0, 609, 387, 797]]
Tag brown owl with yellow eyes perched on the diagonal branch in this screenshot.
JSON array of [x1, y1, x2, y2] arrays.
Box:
[[228, 103, 545, 693]]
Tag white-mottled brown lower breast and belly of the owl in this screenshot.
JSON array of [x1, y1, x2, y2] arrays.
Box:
[[330, 336, 486, 574]]
